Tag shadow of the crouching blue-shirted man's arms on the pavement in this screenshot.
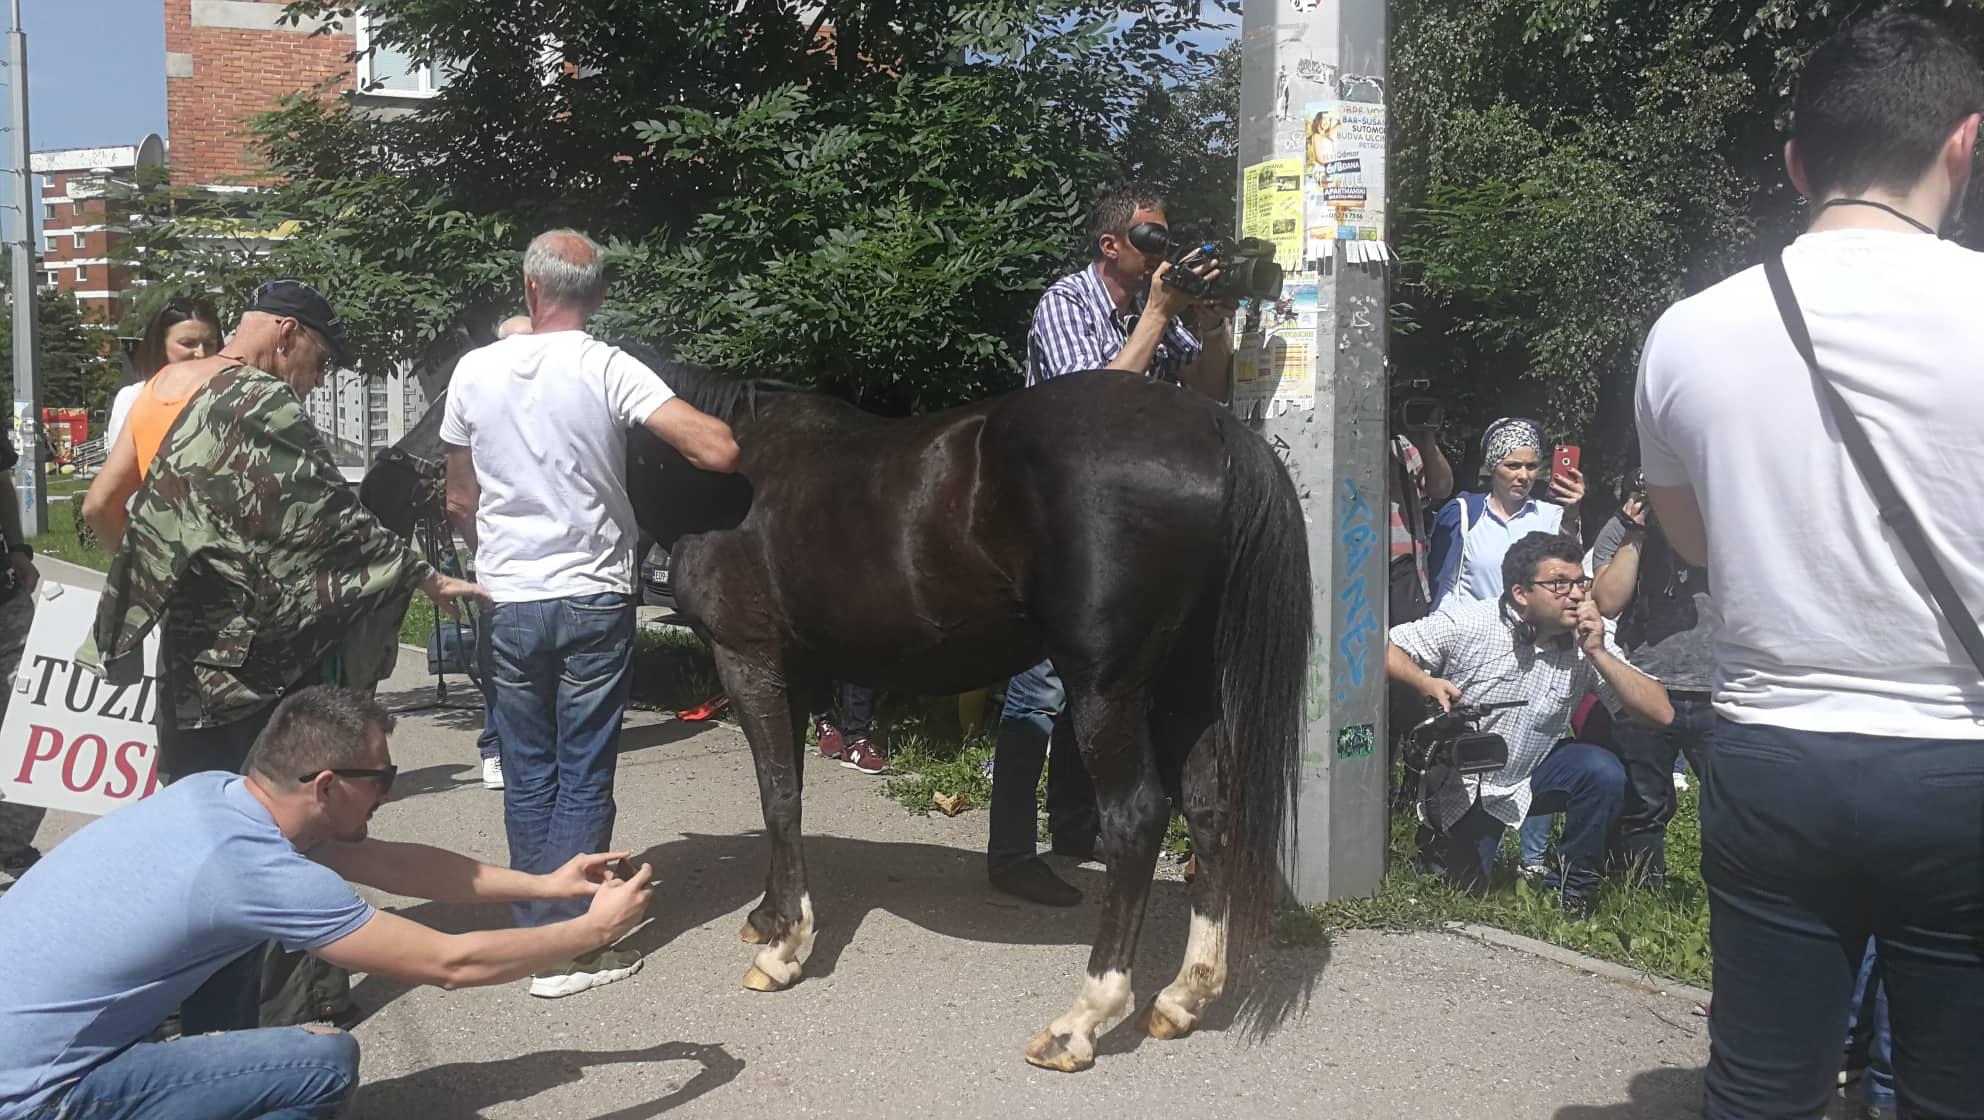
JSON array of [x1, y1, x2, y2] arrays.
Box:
[[349, 1043, 744, 1120]]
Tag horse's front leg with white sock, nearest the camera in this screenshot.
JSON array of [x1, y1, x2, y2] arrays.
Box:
[[716, 646, 813, 991]]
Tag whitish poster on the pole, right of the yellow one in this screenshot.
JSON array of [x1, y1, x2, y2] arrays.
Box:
[[1302, 101, 1385, 260]]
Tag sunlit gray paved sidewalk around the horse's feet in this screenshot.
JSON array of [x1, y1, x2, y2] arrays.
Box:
[[15, 654, 1708, 1120]]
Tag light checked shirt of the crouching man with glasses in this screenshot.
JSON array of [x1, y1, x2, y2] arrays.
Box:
[[1391, 601, 1625, 829]]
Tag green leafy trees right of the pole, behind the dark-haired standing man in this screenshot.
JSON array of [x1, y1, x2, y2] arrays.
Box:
[[1391, 0, 1984, 478]]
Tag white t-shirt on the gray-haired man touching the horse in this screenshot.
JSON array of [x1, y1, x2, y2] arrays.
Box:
[[440, 331, 675, 603]]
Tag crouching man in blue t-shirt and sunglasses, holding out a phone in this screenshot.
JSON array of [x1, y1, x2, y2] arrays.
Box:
[[0, 688, 649, 1120]]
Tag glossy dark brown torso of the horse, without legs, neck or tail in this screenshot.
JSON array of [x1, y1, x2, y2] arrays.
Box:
[[682, 371, 1226, 688]]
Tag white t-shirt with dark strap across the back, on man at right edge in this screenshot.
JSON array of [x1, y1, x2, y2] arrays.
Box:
[[1639, 230, 1984, 739]]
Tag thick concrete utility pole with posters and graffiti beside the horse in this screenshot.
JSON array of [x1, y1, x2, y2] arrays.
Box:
[[1234, 0, 1391, 904]]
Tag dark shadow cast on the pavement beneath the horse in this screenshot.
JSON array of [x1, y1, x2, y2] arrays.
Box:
[[353, 833, 1329, 1053]]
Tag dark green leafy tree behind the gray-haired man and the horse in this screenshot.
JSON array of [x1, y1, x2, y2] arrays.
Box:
[[141, 0, 1218, 410]]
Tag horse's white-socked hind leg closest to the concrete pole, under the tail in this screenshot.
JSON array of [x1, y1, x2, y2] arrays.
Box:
[[1143, 724, 1230, 1039]]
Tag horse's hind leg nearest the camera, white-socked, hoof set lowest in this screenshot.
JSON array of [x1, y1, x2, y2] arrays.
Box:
[[1026, 682, 1169, 1072]]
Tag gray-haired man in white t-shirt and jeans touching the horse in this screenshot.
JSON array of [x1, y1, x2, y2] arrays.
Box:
[[440, 230, 738, 997]]
